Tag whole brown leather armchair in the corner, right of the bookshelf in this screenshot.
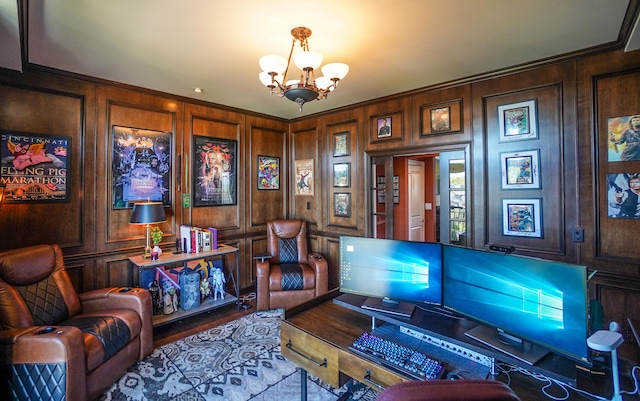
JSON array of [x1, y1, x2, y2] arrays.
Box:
[[255, 220, 329, 310]]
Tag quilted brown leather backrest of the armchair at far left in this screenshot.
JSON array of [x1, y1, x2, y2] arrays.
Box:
[[0, 245, 81, 330]]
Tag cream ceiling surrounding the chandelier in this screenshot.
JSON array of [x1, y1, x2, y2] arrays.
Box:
[[15, 0, 629, 119]]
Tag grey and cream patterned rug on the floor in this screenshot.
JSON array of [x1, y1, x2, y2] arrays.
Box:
[[99, 310, 378, 401]]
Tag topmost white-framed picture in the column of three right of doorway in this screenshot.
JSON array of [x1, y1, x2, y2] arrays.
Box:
[[498, 100, 538, 141]]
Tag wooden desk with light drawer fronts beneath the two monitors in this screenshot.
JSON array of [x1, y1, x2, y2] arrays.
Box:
[[280, 291, 638, 401]]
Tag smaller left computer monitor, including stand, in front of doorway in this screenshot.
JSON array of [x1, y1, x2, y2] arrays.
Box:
[[340, 236, 442, 316]]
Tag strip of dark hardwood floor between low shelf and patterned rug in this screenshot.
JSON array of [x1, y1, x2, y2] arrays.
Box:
[[153, 299, 256, 347]]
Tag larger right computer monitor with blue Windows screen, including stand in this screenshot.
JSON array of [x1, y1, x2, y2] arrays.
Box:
[[442, 245, 589, 365]]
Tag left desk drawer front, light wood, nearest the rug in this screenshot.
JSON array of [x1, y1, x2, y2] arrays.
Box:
[[280, 320, 340, 388]]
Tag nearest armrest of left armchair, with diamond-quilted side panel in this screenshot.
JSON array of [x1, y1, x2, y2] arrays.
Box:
[[0, 326, 86, 400]]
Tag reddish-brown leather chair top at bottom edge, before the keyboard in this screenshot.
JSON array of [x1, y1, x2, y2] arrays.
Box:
[[377, 380, 520, 401]]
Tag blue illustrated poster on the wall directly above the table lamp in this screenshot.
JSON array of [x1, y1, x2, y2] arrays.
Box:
[[111, 125, 171, 209]]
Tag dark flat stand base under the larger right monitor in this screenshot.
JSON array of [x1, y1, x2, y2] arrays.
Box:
[[464, 325, 549, 365]]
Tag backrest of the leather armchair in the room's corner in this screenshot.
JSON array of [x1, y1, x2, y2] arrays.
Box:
[[267, 220, 307, 264]]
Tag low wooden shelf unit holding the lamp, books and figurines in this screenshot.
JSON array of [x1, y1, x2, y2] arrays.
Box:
[[129, 244, 240, 327]]
